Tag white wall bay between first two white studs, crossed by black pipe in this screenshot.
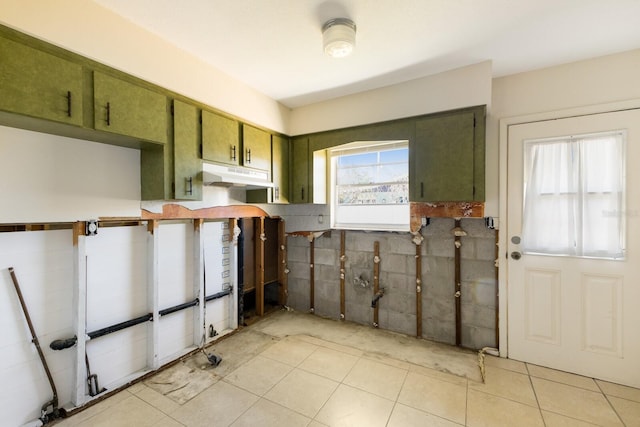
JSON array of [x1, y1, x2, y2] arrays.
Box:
[[86, 226, 151, 388]]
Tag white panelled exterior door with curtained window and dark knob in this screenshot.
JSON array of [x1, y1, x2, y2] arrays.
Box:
[[505, 110, 640, 387]]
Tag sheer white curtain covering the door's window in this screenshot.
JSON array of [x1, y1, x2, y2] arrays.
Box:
[[522, 131, 625, 258]]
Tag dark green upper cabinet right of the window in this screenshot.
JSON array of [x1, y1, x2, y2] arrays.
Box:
[[409, 107, 484, 202]]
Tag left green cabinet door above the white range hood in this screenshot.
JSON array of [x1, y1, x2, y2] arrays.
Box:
[[202, 110, 240, 165]]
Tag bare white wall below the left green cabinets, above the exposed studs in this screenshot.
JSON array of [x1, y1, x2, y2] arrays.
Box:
[[0, 126, 140, 223]]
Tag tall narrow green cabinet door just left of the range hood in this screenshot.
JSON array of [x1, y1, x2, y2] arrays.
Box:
[[173, 100, 202, 200]]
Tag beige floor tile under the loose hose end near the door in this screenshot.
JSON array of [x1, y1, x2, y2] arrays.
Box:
[[469, 366, 538, 406]]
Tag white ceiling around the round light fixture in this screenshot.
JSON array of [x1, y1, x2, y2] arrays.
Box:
[[93, 0, 640, 108]]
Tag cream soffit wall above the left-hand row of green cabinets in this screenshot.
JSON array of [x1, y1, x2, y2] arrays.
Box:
[[0, 0, 288, 133]]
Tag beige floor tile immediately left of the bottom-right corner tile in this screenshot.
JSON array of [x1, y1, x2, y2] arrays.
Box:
[[531, 378, 622, 426]]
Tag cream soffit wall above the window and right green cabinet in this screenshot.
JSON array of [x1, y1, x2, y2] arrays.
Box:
[[289, 61, 491, 135]]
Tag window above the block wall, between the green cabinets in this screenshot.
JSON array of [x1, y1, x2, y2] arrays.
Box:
[[329, 141, 409, 231]]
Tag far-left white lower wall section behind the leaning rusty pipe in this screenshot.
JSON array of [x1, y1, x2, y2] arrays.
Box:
[[0, 230, 75, 426]]
